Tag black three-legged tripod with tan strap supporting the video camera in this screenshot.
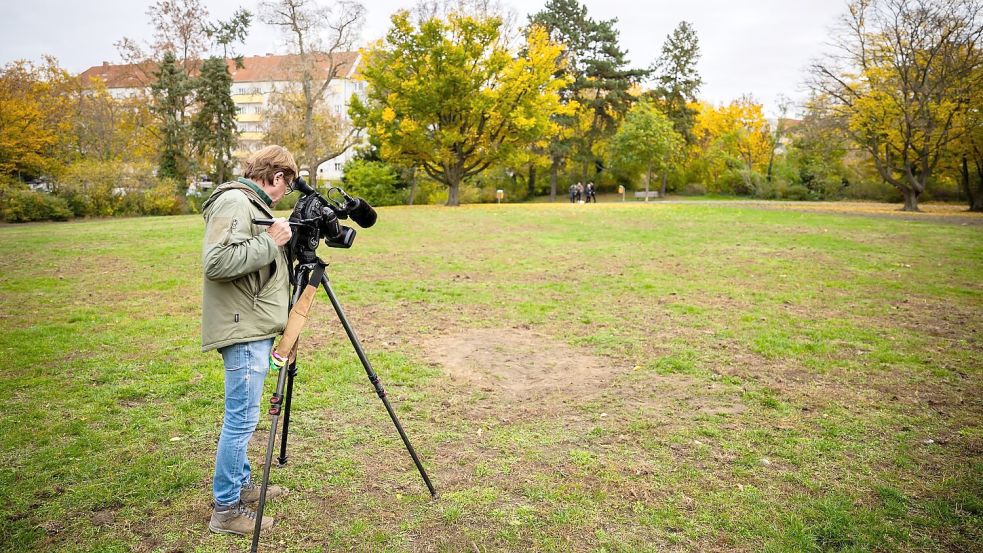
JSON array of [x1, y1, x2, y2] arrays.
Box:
[[250, 256, 437, 553]]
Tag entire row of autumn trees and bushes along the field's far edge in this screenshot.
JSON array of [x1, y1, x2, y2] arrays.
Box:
[[0, 0, 983, 221]]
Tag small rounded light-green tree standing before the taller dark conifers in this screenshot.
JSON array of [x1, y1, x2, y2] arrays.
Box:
[[611, 101, 684, 201]]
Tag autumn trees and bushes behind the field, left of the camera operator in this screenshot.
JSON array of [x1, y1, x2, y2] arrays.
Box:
[[0, 0, 251, 222]]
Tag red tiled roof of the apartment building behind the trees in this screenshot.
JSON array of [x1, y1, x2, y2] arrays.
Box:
[[79, 52, 359, 88]]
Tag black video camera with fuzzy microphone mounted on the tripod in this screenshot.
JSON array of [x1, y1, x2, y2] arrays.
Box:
[[253, 177, 376, 263]]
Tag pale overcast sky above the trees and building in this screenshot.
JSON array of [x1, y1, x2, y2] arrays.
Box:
[[0, 0, 846, 115]]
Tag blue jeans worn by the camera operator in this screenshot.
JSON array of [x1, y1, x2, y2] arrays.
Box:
[[212, 338, 273, 507]]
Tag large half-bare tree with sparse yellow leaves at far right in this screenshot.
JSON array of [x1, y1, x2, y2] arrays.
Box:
[[812, 0, 983, 211]]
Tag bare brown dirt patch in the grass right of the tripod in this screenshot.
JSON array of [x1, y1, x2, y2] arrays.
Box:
[[424, 328, 619, 396]]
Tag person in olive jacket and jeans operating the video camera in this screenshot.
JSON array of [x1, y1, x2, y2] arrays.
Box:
[[201, 146, 297, 535]]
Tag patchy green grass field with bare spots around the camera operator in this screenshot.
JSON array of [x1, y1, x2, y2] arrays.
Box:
[[0, 204, 983, 552]]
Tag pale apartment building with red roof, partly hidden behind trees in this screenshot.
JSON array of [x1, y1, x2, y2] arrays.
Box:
[[80, 52, 365, 181]]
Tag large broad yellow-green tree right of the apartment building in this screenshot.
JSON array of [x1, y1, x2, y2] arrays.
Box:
[[351, 11, 565, 205]]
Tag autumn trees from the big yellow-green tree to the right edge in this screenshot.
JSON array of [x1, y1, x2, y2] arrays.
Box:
[[351, 0, 983, 210]]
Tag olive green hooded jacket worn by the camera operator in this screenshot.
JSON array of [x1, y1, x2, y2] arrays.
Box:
[[201, 179, 290, 351]]
